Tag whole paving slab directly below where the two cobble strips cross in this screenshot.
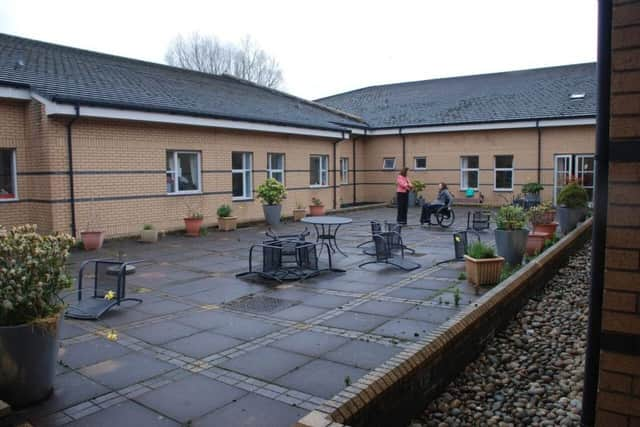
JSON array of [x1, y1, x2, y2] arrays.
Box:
[[135, 375, 247, 425]]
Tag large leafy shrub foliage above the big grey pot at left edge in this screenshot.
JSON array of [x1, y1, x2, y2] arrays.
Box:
[[0, 225, 75, 326]]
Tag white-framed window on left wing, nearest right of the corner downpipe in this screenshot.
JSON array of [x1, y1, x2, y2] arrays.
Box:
[[167, 151, 201, 194]]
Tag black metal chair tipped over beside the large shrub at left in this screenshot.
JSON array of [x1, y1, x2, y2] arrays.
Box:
[[65, 259, 142, 320]]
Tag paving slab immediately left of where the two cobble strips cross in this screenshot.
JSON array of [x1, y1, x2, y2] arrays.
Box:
[[79, 353, 175, 389]]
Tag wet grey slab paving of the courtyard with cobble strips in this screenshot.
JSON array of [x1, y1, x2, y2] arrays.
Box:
[[23, 208, 493, 427]]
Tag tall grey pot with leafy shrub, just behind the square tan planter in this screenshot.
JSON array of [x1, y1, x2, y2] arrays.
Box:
[[495, 205, 529, 265]]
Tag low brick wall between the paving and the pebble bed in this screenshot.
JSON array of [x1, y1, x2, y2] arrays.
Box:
[[296, 219, 592, 427]]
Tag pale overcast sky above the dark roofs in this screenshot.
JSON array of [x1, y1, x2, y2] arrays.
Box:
[[0, 0, 597, 99]]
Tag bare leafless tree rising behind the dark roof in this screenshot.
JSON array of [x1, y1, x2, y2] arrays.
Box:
[[165, 33, 282, 88]]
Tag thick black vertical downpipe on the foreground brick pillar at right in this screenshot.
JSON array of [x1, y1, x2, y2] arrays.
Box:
[[581, 0, 611, 427]]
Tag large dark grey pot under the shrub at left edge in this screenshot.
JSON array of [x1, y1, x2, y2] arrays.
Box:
[[0, 315, 60, 408]]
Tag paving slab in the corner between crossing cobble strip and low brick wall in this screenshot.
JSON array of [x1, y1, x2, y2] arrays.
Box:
[[275, 360, 367, 399]]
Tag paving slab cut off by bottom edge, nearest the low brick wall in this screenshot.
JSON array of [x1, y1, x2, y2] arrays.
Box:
[[193, 393, 308, 427]]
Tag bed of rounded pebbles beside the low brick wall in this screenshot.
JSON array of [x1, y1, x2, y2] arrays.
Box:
[[410, 244, 591, 427]]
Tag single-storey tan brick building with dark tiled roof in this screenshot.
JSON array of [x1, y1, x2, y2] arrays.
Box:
[[0, 35, 596, 236]]
